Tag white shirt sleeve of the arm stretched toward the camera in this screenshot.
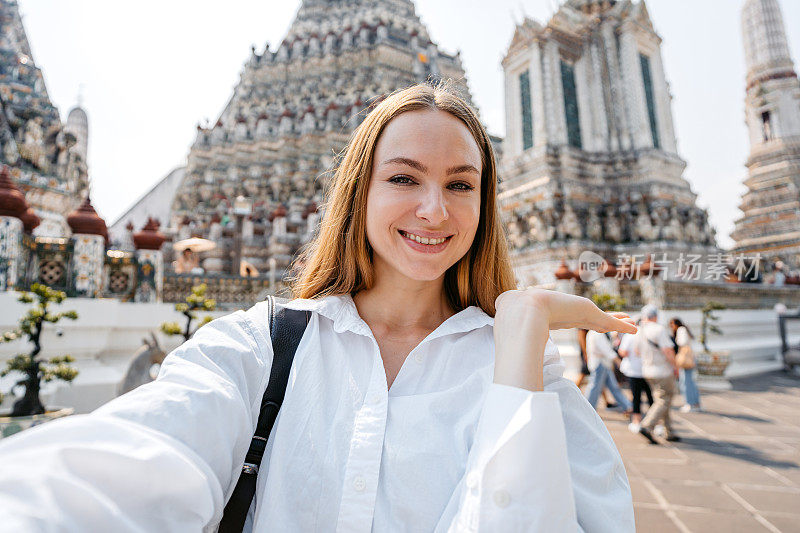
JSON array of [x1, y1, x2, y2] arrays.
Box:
[[0, 308, 272, 532]]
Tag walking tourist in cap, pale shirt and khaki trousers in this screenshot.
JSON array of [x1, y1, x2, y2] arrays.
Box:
[[634, 305, 680, 444]]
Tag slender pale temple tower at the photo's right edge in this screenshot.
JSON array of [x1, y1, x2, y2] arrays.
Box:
[[731, 0, 800, 268]]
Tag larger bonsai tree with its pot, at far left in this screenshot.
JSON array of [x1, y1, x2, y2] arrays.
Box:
[[0, 283, 78, 438]]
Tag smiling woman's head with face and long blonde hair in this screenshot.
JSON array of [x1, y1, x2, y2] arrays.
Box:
[[294, 85, 516, 315]]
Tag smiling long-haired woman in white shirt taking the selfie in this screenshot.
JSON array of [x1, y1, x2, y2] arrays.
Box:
[[0, 84, 635, 533]]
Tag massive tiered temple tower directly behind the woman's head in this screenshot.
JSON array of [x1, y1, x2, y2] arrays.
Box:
[[167, 0, 471, 274]]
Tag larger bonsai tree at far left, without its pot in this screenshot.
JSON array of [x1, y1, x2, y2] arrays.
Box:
[[0, 283, 78, 416]]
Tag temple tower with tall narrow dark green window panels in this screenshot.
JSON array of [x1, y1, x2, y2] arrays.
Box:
[[500, 0, 716, 285]]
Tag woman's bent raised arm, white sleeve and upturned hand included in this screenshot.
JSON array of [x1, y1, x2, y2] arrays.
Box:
[[439, 291, 635, 532]]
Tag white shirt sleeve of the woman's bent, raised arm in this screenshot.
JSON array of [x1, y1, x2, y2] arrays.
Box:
[[437, 341, 635, 532]]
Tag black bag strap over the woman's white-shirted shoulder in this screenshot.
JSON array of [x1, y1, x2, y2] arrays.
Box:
[[217, 296, 311, 533]]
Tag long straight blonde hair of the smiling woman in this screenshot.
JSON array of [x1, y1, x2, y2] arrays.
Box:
[[291, 84, 516, 316]]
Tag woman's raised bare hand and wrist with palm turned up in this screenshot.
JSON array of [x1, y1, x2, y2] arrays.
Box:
[[494, 289, 636, 391]]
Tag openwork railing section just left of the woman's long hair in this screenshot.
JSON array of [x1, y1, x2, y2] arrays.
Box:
[[162, 272, 287, 310]]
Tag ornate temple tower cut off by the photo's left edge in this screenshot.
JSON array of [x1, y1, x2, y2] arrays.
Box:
[[0, 0, 89, 237]]
